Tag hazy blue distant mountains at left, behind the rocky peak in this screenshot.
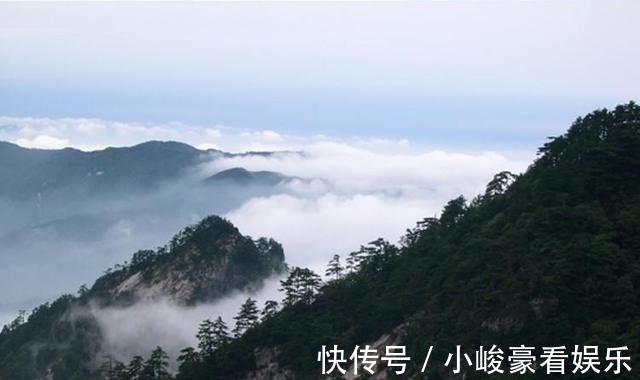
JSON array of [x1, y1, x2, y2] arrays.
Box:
[[0, 141, 298, 315]]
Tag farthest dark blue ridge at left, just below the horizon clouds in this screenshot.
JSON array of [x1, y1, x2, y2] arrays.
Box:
[[0, 141, 210, 199]]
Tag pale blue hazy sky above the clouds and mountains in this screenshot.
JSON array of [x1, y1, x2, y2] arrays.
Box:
[[0, 1, 640, 149]]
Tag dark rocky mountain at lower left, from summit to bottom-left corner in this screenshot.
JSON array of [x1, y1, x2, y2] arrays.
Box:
[[0, 216, 285, 380]]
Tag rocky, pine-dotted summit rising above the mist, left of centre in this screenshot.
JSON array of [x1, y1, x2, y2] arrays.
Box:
[[87, 216, 285, 305]]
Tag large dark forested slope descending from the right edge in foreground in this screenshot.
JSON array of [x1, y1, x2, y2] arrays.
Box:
[[177, 103, 640, 380]]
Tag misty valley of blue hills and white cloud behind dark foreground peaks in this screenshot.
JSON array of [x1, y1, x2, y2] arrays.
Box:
[[0, 128, 525, 322]]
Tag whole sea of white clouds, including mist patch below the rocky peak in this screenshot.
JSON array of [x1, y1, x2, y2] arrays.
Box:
[[0, 117, 534, 360]]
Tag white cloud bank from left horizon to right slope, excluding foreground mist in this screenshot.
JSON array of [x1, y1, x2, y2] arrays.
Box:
[[0, 117, 529, 274]]
